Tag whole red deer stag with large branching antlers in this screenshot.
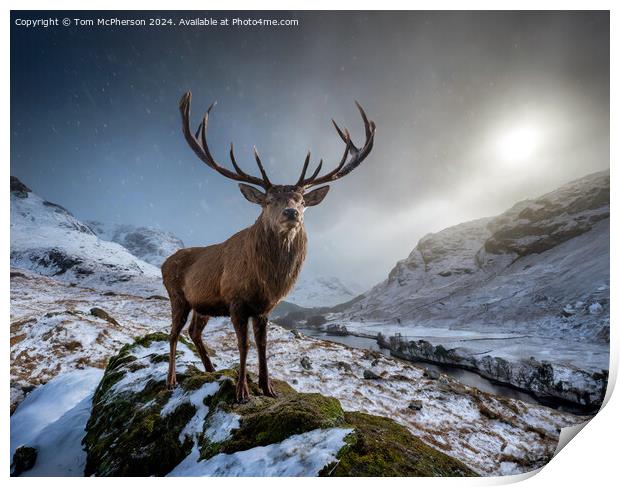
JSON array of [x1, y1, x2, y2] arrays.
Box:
[[162, 92, 375, 402]]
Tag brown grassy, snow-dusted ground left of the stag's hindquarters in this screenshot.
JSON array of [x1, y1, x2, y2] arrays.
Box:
[[10, 269, 169, 407]]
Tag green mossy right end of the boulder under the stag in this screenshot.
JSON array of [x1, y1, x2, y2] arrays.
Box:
[[321, 412, 476, 477]]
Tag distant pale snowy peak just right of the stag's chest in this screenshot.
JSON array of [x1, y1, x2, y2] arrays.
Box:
[[284, 276, 361, 308]]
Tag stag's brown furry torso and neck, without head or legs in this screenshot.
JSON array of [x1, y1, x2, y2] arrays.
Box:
[[162, 212, 307, 316]]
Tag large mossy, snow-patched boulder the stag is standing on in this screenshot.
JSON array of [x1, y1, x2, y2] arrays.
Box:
[[83, 333, 473, 476]]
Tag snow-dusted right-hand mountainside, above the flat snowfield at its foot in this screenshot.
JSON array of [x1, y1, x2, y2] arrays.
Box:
[[347, 171, 609, 323]]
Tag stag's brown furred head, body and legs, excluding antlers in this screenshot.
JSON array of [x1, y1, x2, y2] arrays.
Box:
[[162, 187, 307, 400]]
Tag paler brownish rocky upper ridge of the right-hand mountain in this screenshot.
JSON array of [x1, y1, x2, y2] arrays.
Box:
[[345, 171, 609, 330]]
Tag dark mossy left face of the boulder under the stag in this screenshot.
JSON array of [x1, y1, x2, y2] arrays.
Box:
[[83, 333, 200, 476]]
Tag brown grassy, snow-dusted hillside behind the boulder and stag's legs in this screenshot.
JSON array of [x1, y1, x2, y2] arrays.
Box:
[[11, 272, 584, 474]]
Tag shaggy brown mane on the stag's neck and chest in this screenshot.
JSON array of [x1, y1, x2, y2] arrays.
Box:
[[249, 216, 308, 301]]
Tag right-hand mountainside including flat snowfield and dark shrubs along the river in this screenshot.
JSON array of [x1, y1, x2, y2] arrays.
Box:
[[332, 171, 610, 405]]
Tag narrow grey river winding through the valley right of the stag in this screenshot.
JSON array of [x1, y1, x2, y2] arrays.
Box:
[[299, 328, 542, 404]]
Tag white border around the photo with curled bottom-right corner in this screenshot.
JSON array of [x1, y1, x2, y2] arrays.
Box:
[[0, 0, 620, 487]]
